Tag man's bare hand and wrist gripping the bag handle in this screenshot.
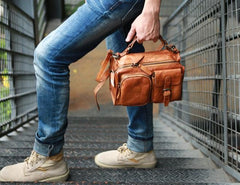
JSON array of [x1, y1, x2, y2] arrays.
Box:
[[126, 0, 161, 43]]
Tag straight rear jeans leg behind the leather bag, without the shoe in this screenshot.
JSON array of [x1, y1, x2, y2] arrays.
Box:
[[106, 28, 153, 152]]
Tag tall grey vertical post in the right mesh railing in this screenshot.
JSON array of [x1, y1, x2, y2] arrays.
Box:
[[221, 0, 228, 164]]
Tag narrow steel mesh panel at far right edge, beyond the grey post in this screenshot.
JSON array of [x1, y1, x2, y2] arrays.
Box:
[[225, 0, 240, 170]]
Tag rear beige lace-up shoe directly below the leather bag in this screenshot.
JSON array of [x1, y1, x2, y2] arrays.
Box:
[[95, 143, 157, 168]]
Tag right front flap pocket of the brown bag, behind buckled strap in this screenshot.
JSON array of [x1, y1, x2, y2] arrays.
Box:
[[152, 68, 183, 103]]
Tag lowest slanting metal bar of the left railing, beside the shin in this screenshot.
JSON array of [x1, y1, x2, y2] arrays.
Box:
[[0, 107, 38, 138]]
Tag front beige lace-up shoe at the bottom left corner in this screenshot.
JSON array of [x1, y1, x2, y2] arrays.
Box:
[[0, 151, 69, 182]]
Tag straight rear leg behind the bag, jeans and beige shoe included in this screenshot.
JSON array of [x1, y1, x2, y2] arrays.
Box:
[[95, 28, 156, 168]]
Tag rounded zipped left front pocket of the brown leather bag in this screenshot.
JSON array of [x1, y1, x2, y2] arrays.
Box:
[[115, 74, 152, 106]]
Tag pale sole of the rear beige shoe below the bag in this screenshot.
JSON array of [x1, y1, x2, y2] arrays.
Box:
[[94, 158, 157, 168]]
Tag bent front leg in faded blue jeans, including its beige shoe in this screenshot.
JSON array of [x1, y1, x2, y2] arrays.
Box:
[[0, 0, 144, 181]]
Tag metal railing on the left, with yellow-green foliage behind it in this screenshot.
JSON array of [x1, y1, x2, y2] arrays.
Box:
[[0, 0, 37, 137]]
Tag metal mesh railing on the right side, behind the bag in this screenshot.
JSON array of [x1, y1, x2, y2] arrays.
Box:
[[161, 0, 240, 180]]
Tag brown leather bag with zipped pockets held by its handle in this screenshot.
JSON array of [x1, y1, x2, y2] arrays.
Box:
[[94, 36, 184, 109]]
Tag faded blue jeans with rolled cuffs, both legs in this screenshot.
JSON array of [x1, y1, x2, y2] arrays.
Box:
[[33, 0, 153, 156]]
